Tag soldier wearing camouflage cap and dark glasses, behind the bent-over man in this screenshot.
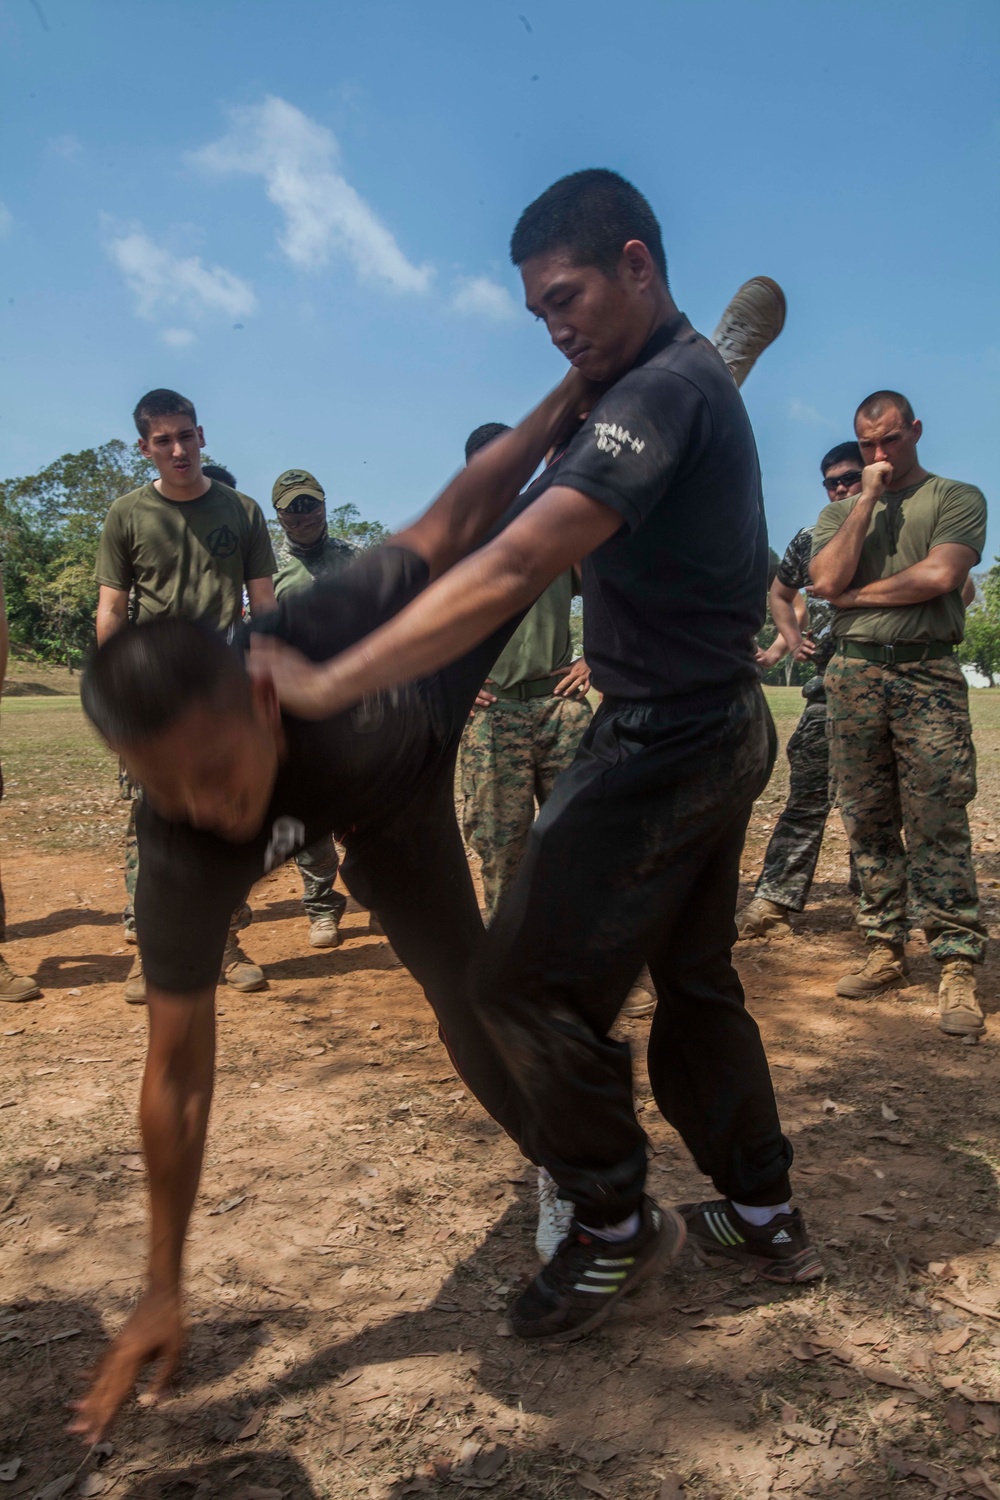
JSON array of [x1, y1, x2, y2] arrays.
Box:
[[271, 470, 355, 948]]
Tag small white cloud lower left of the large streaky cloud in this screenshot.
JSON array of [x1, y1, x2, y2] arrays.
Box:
[[108, 230, 256, 318]]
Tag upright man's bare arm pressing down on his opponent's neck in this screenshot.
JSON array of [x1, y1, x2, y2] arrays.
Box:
[[250, 480, 622, 719]]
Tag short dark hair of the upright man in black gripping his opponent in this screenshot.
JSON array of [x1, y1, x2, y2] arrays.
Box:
[[510, 167, 667, 282]]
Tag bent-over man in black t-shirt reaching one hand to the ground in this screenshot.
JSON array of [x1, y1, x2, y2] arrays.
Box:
[[73, 363, 589, 1442]]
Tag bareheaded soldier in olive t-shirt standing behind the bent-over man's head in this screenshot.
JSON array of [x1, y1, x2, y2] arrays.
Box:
[[94, 390, 277, 1005]]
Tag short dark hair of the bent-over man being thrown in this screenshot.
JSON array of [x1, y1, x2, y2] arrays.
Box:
[[79, 618, 250, 746]]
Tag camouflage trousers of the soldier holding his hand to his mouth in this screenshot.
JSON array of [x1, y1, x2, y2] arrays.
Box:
[[826, 656, 987, 963]]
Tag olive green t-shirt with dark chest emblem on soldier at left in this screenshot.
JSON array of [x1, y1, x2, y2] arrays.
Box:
[[94, 480, 277, 630]]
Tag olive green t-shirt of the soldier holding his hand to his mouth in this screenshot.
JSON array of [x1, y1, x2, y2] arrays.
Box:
[[813, 474, 987, 645]]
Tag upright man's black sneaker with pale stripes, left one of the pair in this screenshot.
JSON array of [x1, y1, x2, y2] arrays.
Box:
[[510, 1197, 685, 1344]]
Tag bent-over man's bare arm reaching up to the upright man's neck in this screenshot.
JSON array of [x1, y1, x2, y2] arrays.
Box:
[[391, 369, 593, 579]]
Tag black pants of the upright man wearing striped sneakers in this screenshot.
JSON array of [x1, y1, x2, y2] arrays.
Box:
[[474, 684, 792, 1226]]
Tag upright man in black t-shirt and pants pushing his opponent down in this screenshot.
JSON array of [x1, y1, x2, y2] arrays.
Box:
[[256, 171, 822, 1338]]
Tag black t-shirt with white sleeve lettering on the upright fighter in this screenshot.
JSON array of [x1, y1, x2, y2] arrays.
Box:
[[529, 314, 768, 699]]
